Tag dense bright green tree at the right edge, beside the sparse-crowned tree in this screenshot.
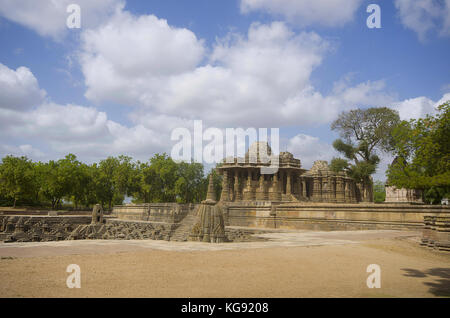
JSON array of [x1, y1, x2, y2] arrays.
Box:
[[387, 101, 450, 203]]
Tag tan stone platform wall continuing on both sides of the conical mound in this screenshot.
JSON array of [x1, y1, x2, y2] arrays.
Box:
[[113, 201, 450, 231]]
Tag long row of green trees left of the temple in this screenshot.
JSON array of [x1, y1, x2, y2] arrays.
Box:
[[0, 154, 221, 209]]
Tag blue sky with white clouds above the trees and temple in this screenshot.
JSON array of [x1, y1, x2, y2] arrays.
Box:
[[0, 0, 450, 180]]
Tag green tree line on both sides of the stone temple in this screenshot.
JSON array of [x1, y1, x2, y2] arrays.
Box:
[[0, 102, 450, 209]]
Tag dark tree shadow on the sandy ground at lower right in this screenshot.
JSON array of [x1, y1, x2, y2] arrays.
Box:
[[402, 268, 450, 297]]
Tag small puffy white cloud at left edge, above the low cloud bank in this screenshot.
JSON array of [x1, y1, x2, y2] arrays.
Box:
[[0, 63, 46, 110]]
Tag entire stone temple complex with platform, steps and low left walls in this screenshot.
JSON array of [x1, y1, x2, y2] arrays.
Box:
[[0, 142, 450, 251]]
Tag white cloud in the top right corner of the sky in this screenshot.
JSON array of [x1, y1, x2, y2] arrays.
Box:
[[395, 0, 450, 41]]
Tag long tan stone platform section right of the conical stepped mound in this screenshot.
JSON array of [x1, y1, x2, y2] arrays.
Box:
[[224, 202, 450, 231]]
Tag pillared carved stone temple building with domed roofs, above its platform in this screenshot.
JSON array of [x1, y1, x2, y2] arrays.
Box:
[[216, 142, 373, 203]]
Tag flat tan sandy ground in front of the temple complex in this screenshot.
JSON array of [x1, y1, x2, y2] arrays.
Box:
[[0, 231, 450, 297]]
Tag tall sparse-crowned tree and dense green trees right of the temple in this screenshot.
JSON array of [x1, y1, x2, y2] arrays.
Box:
[[330, 101, 450, 203]]
